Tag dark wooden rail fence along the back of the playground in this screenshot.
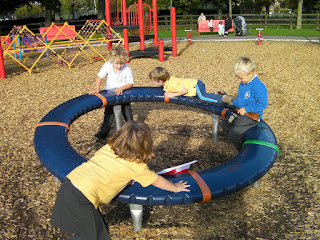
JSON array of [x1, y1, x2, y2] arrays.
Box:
[[0, 13, 320, 35]]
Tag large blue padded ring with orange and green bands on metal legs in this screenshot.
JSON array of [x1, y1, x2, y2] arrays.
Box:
[[34, 87, 279, 230]]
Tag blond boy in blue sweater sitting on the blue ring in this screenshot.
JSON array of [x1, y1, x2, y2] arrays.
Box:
[[221, 57, 268, 151]]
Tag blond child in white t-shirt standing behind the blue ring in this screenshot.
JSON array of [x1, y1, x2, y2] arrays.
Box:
[[89, 47, 134, 139]]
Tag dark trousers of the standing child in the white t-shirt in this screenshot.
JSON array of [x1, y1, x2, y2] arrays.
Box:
[[98, 103, 133, 137]]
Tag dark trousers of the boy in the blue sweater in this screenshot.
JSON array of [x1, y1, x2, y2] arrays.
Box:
[[221, 116, 258, 151]]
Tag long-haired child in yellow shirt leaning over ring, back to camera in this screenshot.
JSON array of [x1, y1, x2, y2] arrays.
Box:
[[51, 121, 190, 240]]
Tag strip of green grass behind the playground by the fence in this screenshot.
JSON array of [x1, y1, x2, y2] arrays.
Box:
[[158, 26, 320, 38]]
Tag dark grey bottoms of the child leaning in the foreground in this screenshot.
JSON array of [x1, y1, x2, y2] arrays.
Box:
[[50, 178, 110, 240]]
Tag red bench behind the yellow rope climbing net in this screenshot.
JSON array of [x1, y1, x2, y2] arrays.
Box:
[[39, 24, 76, 41]]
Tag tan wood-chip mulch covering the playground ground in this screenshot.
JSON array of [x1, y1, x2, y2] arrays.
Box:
[[0, 41, 320, 240]]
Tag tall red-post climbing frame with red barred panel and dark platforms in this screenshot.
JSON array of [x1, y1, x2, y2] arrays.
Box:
[[106, 0, 177, 58]]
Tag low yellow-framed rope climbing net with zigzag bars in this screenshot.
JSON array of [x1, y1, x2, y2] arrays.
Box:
[[2, 20, 123, 74]]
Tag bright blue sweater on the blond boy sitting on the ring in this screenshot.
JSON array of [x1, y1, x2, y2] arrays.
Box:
[[232, 76, 268, 119]]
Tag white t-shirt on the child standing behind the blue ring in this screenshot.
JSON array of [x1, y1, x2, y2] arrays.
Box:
[[98, 61, 134, 90]]
